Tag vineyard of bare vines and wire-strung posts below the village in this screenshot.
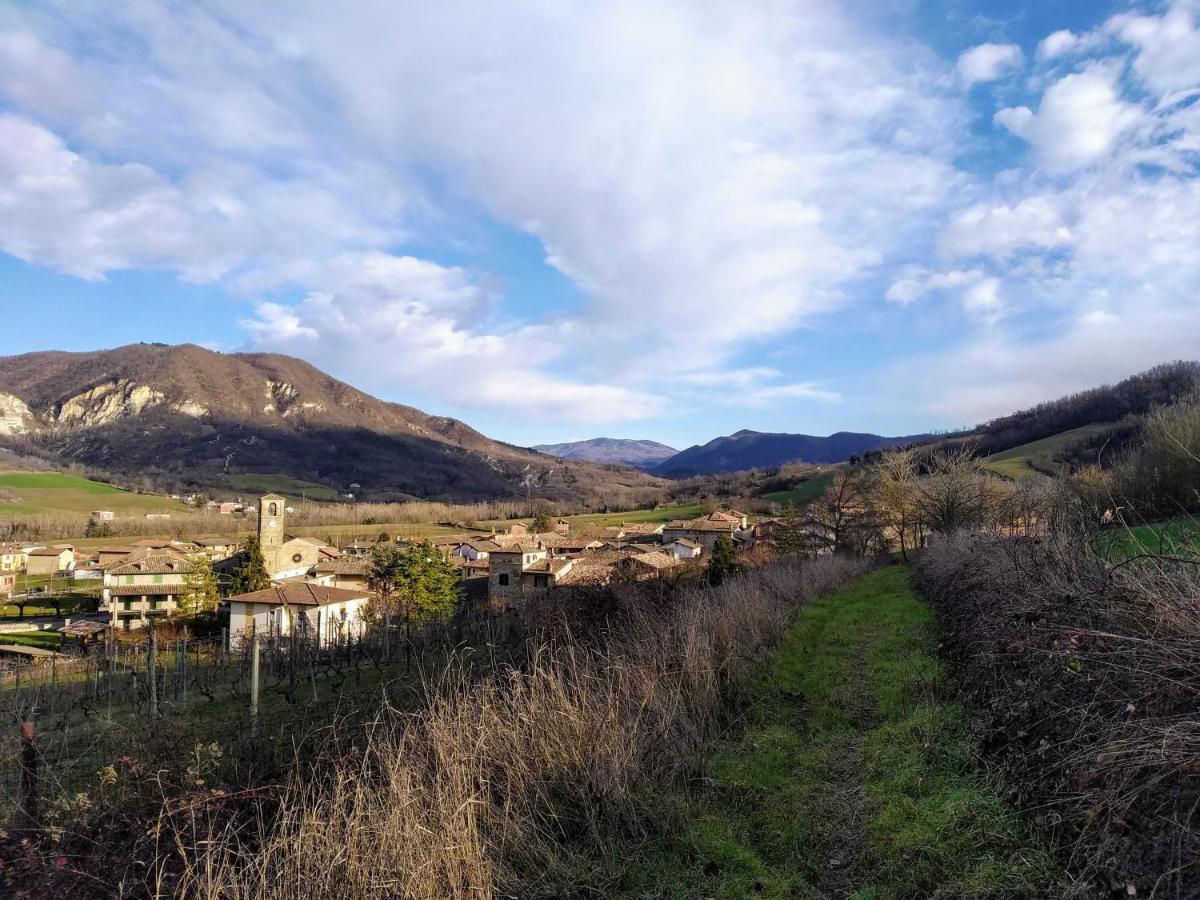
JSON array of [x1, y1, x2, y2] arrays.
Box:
[[0, 611, 529, 826]]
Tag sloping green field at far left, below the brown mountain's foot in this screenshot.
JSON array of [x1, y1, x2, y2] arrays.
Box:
[[0, 472, 186, 518]]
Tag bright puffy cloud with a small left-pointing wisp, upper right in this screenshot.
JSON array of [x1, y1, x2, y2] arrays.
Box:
[[996, 66, 1142, 174]]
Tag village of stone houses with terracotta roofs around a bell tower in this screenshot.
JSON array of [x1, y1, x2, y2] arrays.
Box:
[[0, 494, 776, 655]]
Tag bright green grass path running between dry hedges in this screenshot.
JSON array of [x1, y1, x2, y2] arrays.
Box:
[[617, 566, 1054, 900]]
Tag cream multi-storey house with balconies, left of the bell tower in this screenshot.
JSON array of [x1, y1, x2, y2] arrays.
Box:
[[100, 550, 192, 630]]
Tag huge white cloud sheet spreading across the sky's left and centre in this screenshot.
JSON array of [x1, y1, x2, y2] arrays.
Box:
[[0, 0, 965, 427]]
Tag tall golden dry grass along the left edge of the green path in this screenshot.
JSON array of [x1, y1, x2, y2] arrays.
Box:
[[171, 559, 864, 900]]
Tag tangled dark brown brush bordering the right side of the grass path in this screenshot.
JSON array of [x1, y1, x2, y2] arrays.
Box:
[[917, 526, 1200, 898]]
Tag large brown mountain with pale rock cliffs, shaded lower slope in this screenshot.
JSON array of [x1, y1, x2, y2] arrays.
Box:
[[0, 344, 655, 500]]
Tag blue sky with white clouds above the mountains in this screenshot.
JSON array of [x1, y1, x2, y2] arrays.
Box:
[[0, 0, 1200, 448]]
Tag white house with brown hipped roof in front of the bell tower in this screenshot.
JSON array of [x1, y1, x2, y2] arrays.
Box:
[[228, 581, 371, 647]]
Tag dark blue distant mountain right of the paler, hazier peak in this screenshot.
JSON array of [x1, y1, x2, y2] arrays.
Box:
[[653, 431, 930, 478]]
